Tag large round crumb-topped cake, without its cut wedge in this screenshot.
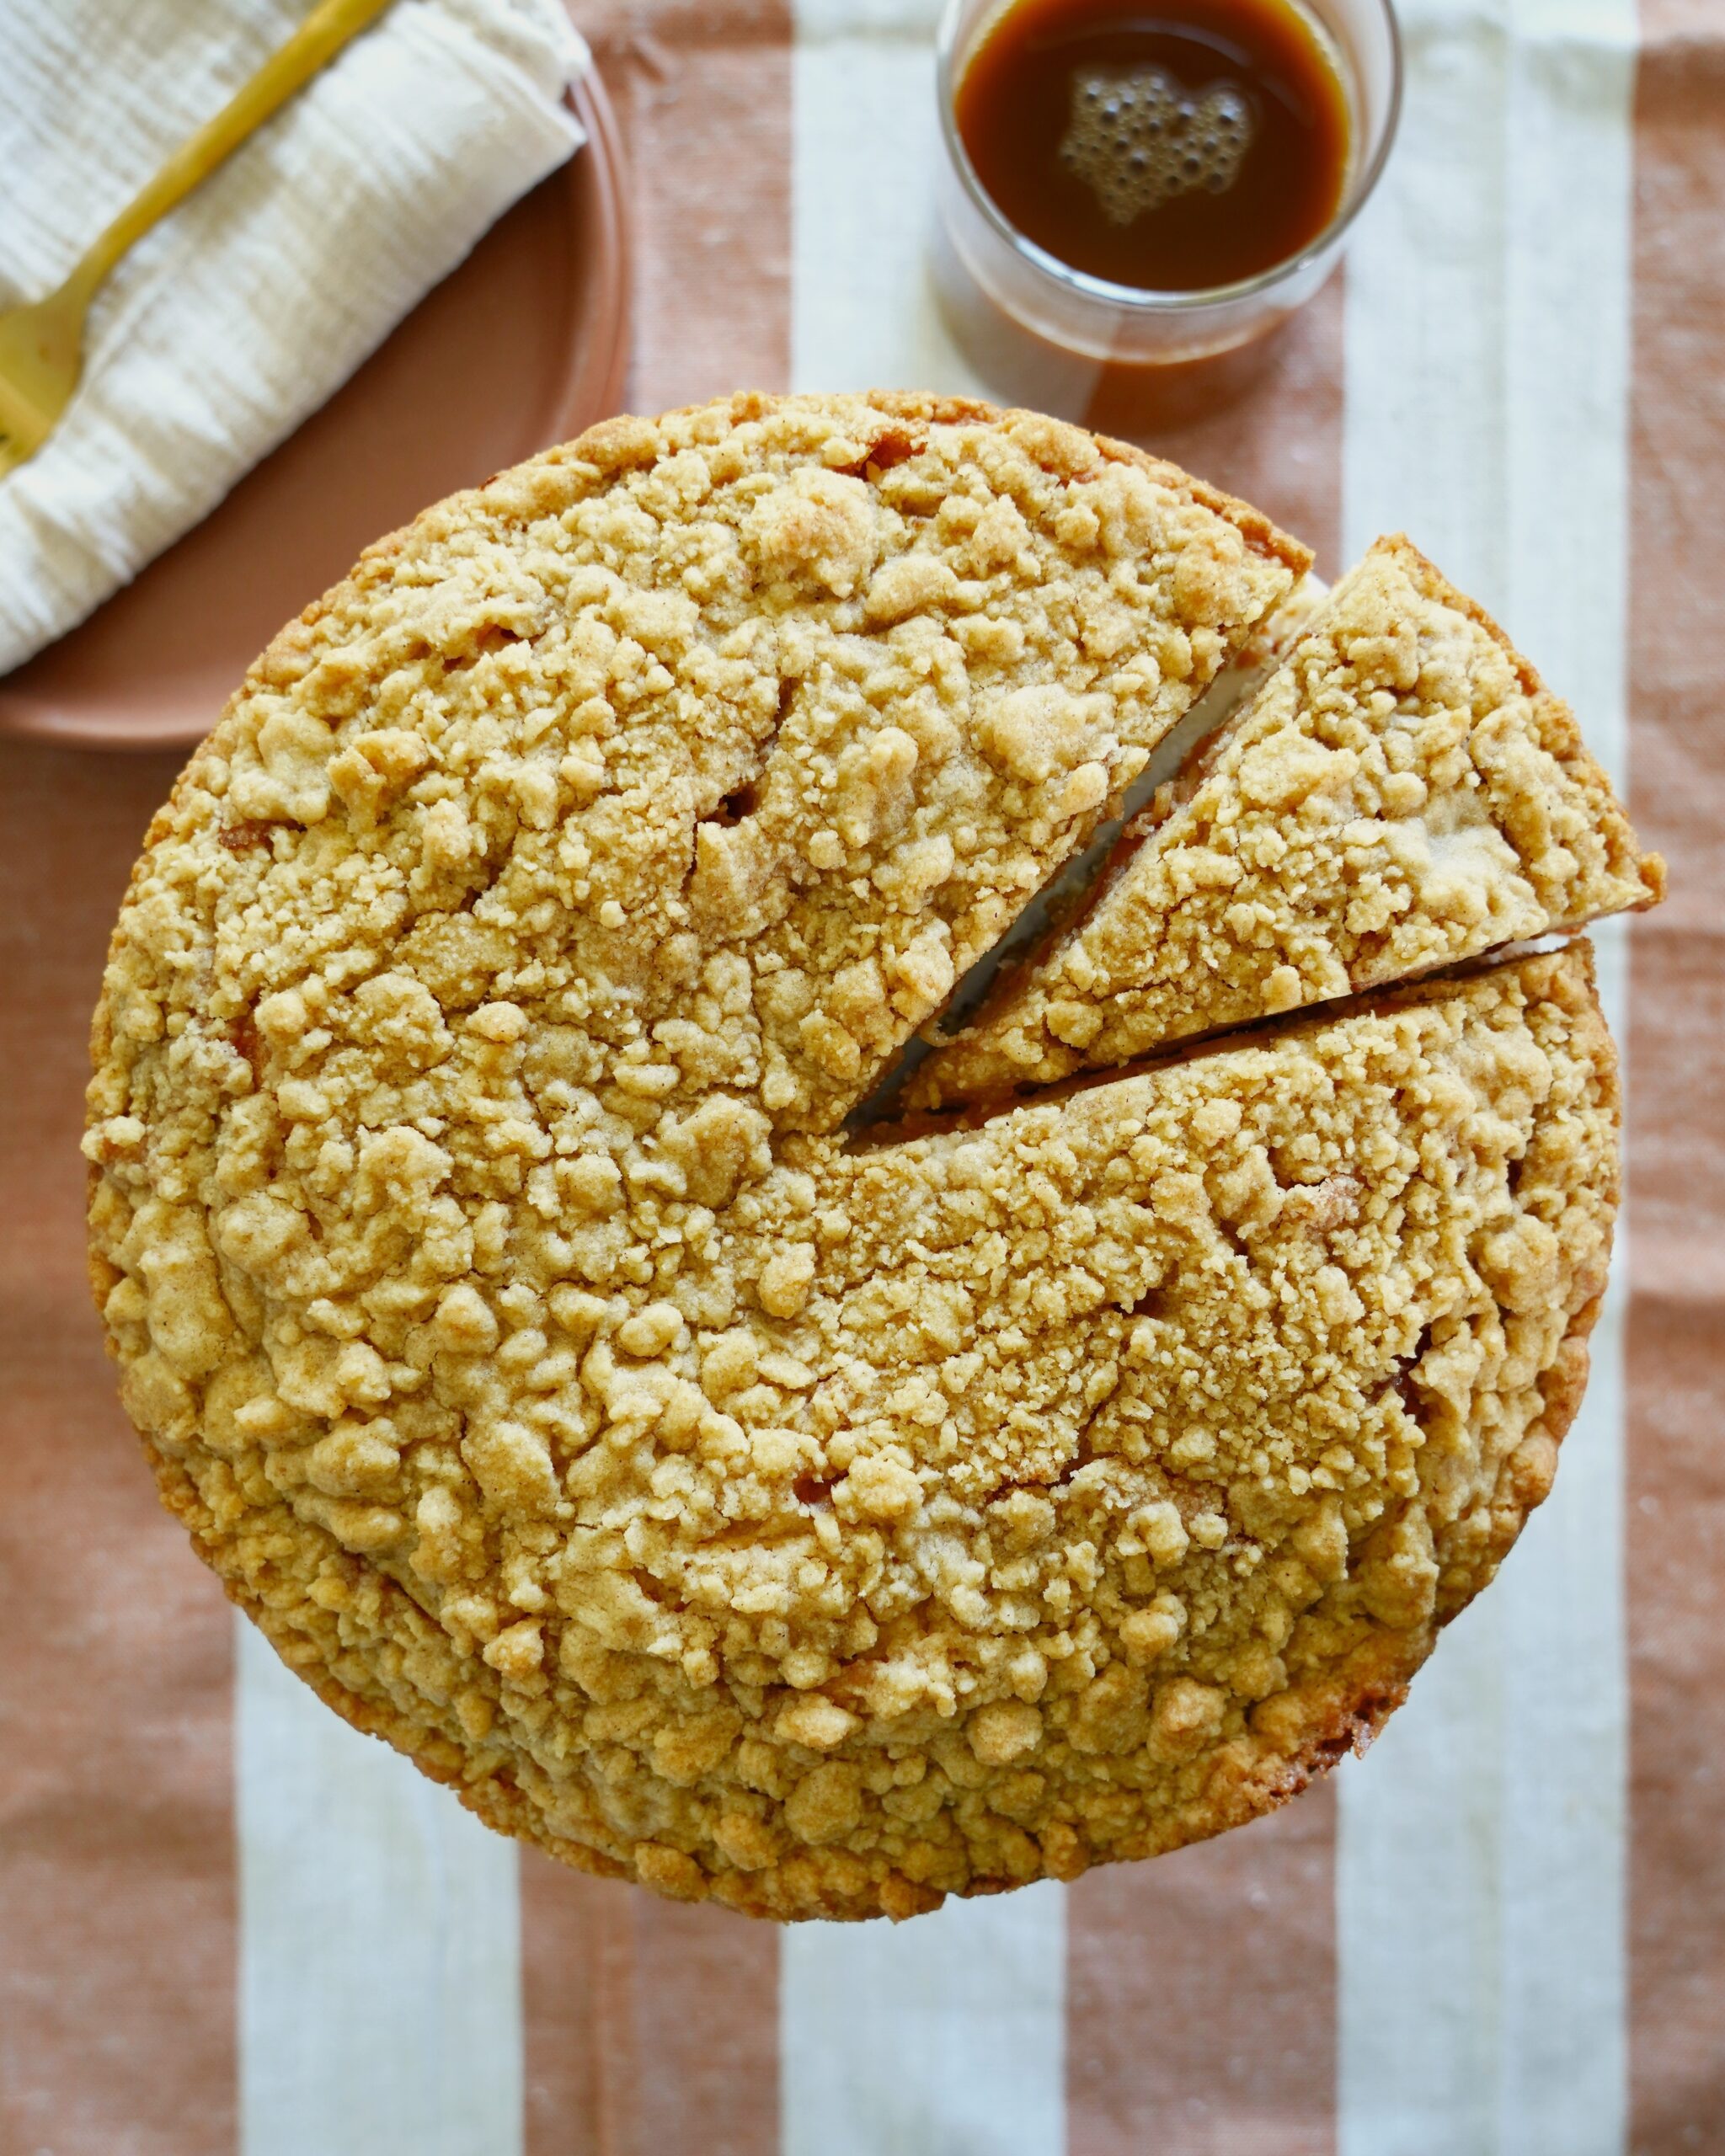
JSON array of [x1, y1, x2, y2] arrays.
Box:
[[86, 397, 1647, 1919]]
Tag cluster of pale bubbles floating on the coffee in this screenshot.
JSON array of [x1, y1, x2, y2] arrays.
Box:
[[1061, 65, 1252, 224]]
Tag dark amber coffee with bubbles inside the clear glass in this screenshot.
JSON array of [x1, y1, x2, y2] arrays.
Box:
[[953, 0, 1352, 291]]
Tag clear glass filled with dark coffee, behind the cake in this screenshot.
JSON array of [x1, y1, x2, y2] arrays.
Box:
[[933, 0, 1402, 390]]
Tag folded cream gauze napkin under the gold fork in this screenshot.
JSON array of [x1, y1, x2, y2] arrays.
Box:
[[0, 0, 586, 673]]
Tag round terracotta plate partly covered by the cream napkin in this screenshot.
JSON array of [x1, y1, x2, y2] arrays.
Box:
[[0, 73, 632, 748]]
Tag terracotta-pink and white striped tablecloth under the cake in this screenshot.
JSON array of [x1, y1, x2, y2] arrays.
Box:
[[0, 0, 1725, 2156]]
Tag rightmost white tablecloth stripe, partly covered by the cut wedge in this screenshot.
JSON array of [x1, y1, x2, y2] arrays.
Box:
[[1337, 0, 1634, 2156]]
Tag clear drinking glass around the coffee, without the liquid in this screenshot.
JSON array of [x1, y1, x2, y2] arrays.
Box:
[[932, 0, 1402, 403]]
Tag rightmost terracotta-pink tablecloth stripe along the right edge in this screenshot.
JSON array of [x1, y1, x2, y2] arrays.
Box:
[[1628, 0, 1725, 2156]]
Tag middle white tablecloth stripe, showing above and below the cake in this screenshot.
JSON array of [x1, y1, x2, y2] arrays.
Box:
[[778, 0, 1065, 2156]]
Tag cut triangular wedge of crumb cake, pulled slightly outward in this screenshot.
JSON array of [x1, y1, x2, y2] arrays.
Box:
[[905, 536, 1664, 1108]]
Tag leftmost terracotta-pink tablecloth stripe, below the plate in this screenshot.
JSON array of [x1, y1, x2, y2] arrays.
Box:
[[0, 744, 238, 2156]]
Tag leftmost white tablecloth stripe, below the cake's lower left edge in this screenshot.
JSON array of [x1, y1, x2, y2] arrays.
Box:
[[235, 1620, 522, 2156]]
